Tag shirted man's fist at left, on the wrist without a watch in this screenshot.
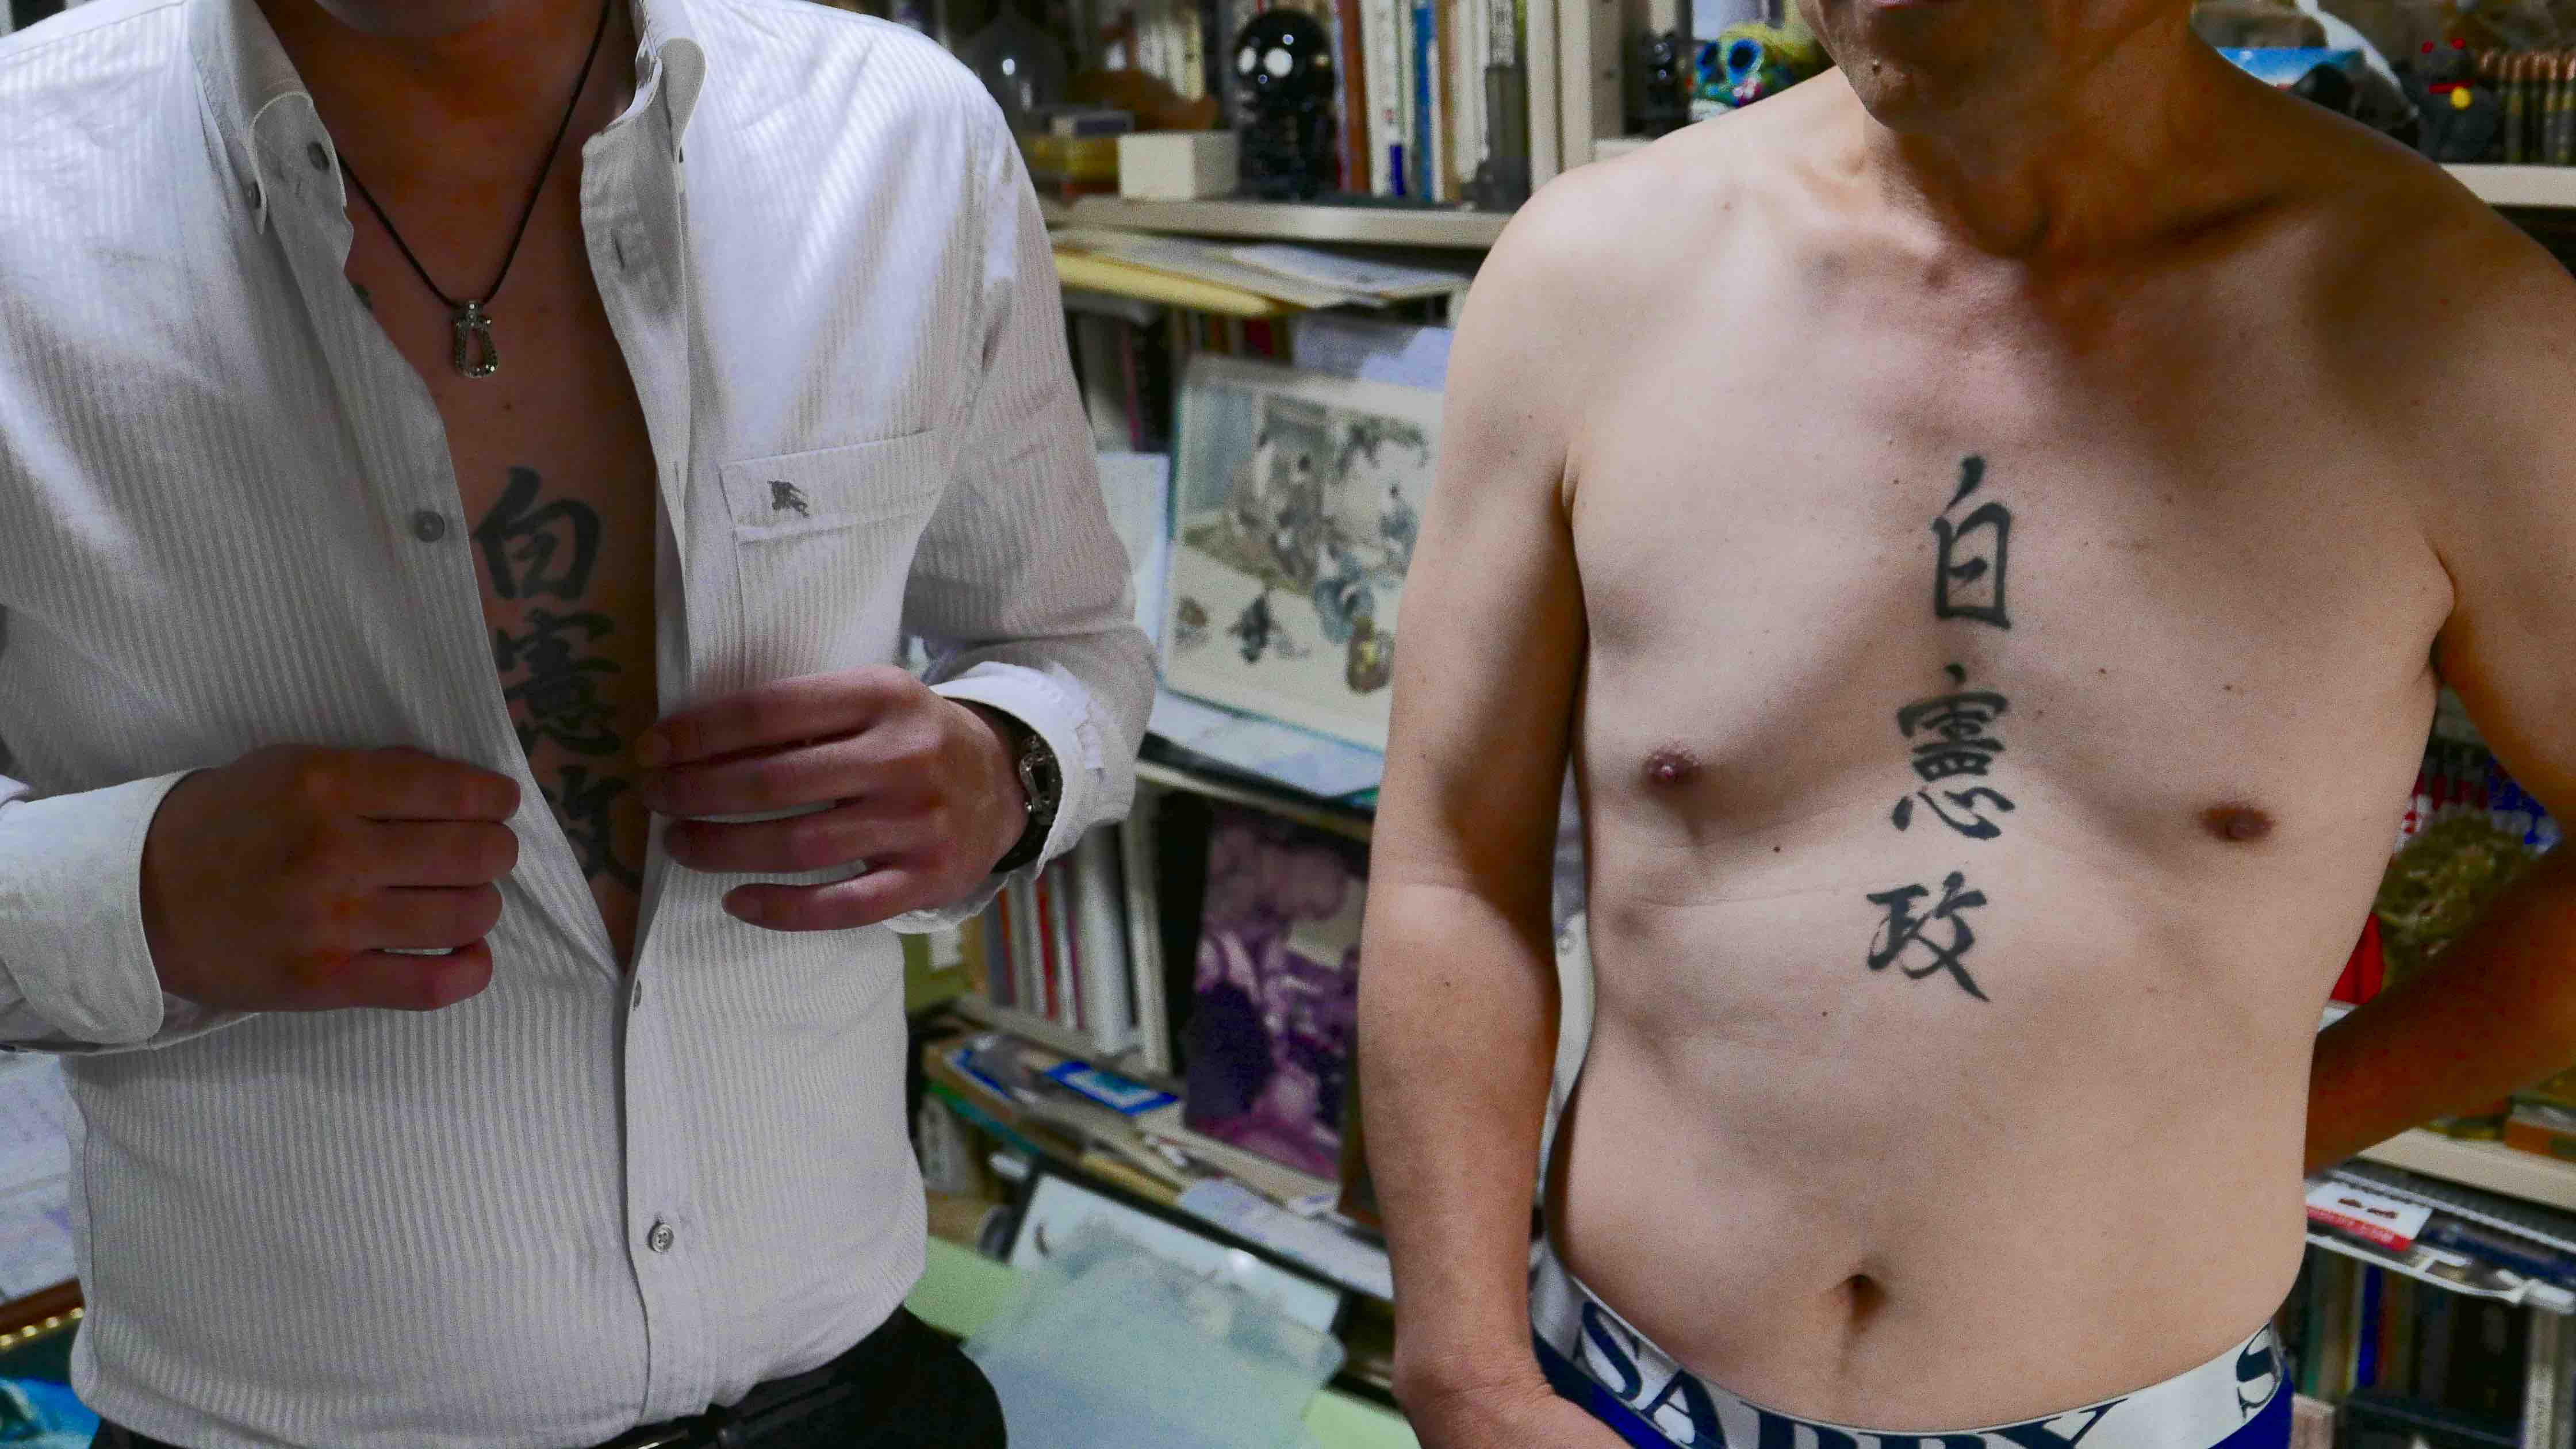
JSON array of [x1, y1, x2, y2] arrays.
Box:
[[141, 745, 518, 1011]]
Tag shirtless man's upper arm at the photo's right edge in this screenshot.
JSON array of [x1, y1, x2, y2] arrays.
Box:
[[2426, 237, 2576, 820]]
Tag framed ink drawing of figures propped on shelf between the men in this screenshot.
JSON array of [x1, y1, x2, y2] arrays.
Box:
[[1162, 356, 1440, 750]]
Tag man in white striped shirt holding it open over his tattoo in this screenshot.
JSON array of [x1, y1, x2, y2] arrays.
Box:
[[0, 0, 1152, 1449]]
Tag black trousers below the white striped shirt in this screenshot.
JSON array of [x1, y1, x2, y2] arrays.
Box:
[[90, 1310, 1007, 1449]]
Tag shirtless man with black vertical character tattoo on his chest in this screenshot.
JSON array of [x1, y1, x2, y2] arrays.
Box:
[[1360, 0, 2576, 1449]]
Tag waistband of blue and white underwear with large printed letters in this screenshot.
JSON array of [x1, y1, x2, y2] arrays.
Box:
[[1530, 1227, 2290, 1449]]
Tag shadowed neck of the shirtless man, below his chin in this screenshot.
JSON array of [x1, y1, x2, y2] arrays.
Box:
[[1862, 10, 2241, 260]]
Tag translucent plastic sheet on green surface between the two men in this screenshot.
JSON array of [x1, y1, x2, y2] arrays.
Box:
[[966, 1220, 1342, 1449]]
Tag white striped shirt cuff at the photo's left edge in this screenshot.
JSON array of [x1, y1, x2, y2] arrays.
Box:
[[0, 771, 188, 1049]]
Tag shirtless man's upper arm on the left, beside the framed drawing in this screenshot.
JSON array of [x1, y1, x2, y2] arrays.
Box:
[[1370, 183, 1584, 921]]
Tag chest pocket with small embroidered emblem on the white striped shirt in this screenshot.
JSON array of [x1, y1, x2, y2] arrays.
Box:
[[716, 433, 948, 678]]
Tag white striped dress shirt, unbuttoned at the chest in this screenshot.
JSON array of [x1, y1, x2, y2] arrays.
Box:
[[0, 0, 1152, 1449]]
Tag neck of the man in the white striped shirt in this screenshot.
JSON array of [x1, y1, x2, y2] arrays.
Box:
[[258, 0, 634, 196]]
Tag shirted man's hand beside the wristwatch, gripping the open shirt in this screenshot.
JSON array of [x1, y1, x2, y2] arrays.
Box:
[[634, 665, 1028, 931]]
